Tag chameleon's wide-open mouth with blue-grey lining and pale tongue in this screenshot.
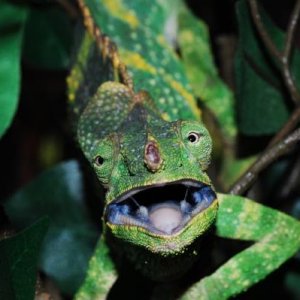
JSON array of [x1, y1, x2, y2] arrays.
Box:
[[106, 180, 216, 235]]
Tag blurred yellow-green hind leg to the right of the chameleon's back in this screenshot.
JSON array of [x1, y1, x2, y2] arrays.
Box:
[[179, 3, 236, 139]]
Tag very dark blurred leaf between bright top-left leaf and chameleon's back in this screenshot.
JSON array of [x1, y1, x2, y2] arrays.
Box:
[[23, 6, 73, 70]]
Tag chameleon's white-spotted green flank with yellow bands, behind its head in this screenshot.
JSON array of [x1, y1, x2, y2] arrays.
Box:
[[79, 0, 200, 121]]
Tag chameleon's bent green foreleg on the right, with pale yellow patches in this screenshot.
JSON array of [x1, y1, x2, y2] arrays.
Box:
[[182, 194, 300, 299]]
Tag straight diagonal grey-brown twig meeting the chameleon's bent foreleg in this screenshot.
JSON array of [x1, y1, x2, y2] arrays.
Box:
[[229, 128, 300, 195]]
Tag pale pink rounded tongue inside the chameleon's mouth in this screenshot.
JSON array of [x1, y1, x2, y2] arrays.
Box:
[[149, 206, 182, 233]]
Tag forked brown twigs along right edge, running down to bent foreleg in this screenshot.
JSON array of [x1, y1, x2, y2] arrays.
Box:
[[229, 0, 300, 194]]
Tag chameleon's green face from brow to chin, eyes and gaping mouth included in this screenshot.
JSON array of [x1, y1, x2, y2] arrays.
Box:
[[86, 105, 218, 255]]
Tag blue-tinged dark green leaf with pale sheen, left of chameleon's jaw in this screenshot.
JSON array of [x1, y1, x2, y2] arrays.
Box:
[[4, 161, 100, 294]]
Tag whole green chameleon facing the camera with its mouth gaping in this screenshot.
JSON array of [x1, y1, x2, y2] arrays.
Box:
[[68, 0, 300, 299]]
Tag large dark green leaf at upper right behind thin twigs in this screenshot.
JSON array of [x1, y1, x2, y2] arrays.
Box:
[[235, 0, 289, 135]]
